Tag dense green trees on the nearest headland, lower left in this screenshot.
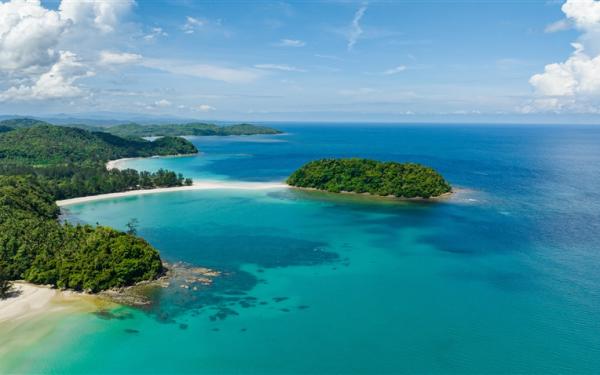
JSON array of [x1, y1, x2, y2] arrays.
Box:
[[0, 176, 163, 292]]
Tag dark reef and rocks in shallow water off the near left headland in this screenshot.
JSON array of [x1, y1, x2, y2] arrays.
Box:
[[131, 233, 342, 323]]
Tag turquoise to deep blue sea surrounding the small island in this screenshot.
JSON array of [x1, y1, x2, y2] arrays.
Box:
[[0, 123, 600, 374]]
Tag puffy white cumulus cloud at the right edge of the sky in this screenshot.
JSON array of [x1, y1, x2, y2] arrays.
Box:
[[524, 0, 600, 112]]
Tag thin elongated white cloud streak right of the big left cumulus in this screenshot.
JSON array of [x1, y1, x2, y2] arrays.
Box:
[[141, 59, 260, 83]]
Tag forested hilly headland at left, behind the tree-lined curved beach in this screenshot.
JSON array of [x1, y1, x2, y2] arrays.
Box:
[[0, 125, 198, 165]]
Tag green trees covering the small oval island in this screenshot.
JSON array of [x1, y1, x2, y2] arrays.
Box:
[[287, 158, 452, 198]]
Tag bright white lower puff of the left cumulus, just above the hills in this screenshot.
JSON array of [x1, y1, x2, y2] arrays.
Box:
[[0, 51, 94, 101]]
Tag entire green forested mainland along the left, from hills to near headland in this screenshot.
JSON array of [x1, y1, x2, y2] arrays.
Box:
[[0, 121, 198, 294]]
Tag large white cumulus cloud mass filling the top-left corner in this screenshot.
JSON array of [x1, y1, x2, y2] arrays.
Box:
[[0, 0, 134, 101]]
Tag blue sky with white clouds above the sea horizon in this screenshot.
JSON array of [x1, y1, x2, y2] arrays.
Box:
[[0, 0, 600, 124]]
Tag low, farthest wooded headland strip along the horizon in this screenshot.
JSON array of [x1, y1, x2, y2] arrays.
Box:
[[104, 123, 281, 137]]
